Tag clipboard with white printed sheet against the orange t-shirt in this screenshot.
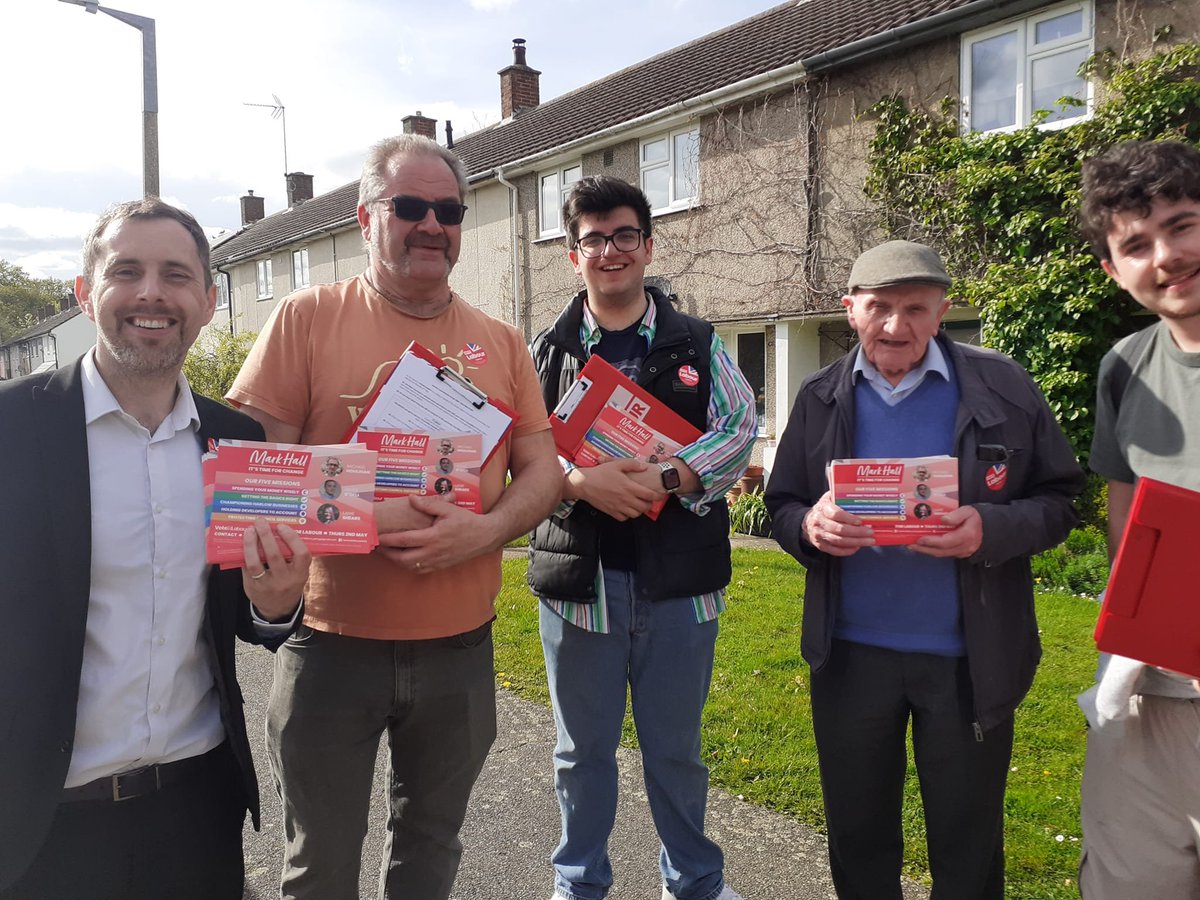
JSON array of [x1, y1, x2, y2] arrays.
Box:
[[346, 341, 518, 466]]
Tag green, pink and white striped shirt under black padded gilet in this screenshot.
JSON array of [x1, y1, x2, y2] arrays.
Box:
[[542, 302, 758, 634]]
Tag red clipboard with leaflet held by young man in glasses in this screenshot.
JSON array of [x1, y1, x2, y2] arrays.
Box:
[[550, 356, 702, 520]]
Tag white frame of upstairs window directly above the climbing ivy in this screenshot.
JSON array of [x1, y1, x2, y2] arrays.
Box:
[[959, 0, 1096, 134]]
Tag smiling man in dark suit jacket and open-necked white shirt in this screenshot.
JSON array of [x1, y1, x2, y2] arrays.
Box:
[[0, 199, 308, 900]]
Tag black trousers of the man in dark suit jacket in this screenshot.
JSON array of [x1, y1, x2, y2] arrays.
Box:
[[0, 744, 246, 900]]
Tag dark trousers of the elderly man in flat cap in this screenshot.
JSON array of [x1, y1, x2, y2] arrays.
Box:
[[812, 641, 1013, 900]]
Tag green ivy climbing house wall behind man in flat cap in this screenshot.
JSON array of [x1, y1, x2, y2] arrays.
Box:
[[866, 43, 1200, 460]]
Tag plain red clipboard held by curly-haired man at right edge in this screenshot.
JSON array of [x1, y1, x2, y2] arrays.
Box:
[[1096, 478, 1200, 677]]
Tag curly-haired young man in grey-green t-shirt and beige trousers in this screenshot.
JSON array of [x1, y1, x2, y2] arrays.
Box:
[[1080, 142, 1200, 900]]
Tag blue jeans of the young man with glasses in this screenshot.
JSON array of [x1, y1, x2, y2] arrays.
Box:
[[541, 571, 725, 900]]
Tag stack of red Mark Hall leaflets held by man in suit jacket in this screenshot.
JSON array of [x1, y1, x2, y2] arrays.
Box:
[[204, 440, 379, 568]]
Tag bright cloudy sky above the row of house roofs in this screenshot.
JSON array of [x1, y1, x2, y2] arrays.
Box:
[[0, 0, 778, 278]]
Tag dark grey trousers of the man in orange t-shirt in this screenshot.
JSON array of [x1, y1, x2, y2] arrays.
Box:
[[266, 623, 496, 900]]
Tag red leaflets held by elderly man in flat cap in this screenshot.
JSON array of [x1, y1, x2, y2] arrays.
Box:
[[829, 456, 959, 546]]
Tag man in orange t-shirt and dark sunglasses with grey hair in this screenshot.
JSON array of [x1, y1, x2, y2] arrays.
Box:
[[228, 134, 562, 900]]
